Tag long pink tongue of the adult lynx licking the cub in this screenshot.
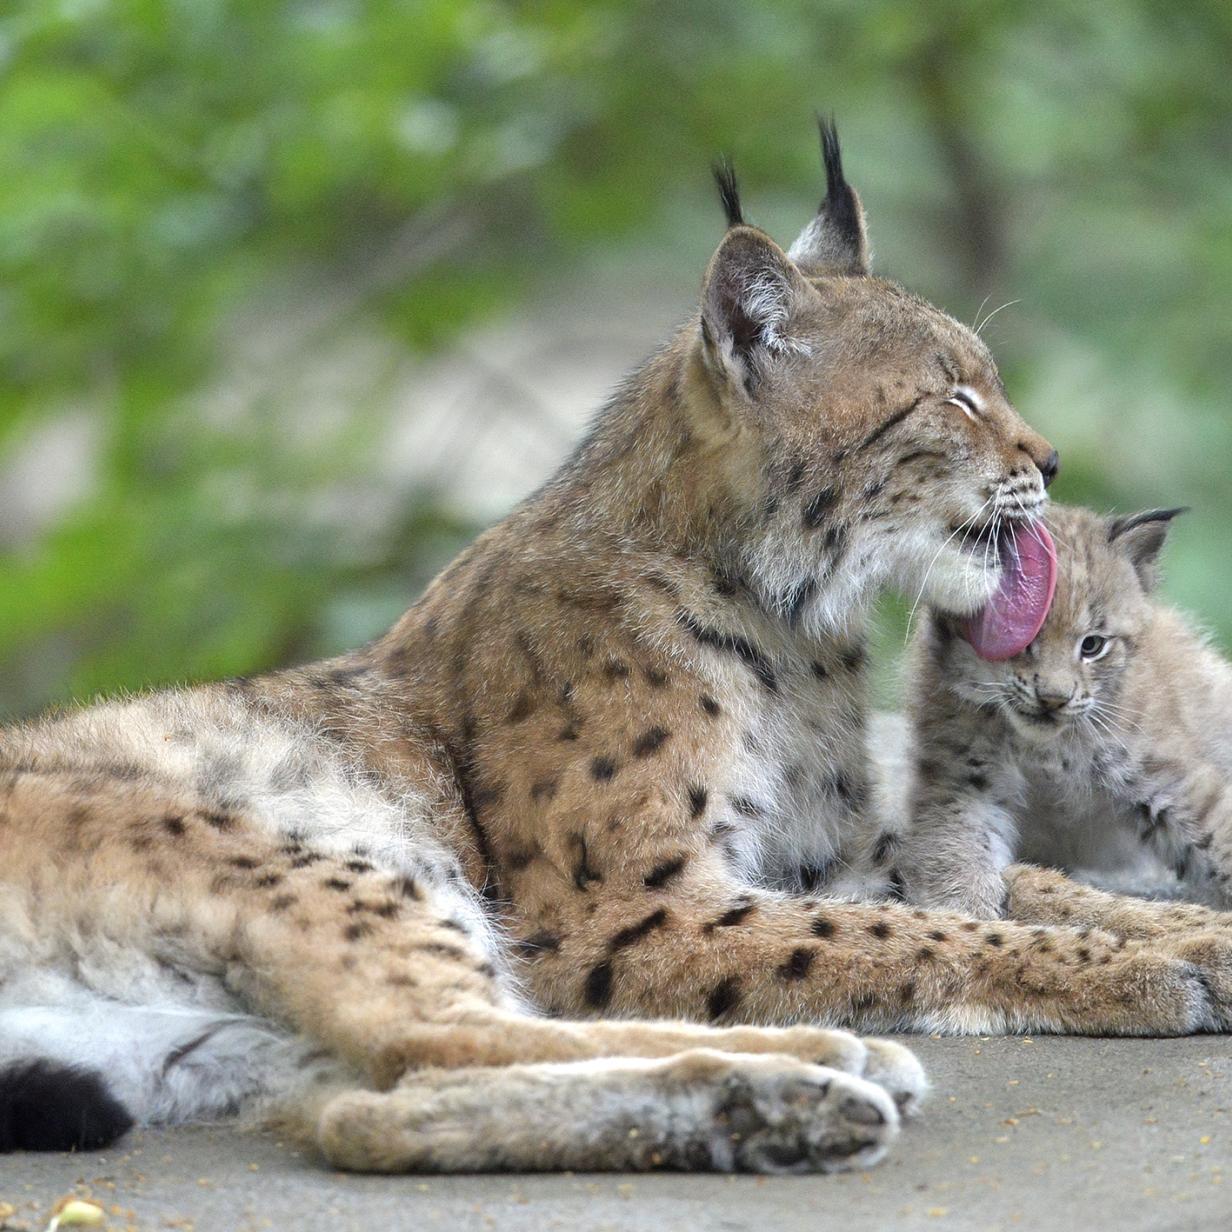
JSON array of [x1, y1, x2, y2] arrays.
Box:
[[966, 522, 1057, 663]]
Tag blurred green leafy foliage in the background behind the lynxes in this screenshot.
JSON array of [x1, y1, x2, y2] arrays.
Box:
[[0, 0, 1232, 713]]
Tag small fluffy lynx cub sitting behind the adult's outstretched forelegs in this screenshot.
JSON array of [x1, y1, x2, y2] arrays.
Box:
[[898, 506, 1232, 918]]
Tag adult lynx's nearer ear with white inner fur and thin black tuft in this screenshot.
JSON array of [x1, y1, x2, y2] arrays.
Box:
[[701, 179, 812, 397]]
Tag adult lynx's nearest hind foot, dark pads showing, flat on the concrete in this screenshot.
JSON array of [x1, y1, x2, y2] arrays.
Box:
[[318, 1048, 898, 1173]]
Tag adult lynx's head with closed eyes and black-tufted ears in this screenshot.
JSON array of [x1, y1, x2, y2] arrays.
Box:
[[692, 121, 1057, 627]]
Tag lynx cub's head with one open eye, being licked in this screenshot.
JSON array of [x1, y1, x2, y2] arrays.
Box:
[[929, 505, 1183, 743]]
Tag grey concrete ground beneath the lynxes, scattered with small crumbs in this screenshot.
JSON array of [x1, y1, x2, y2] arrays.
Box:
[[0, 1036, 1232, 1232]]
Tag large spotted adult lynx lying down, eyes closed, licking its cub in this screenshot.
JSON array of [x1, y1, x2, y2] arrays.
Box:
[[0, 125, 1225, 1172]]
